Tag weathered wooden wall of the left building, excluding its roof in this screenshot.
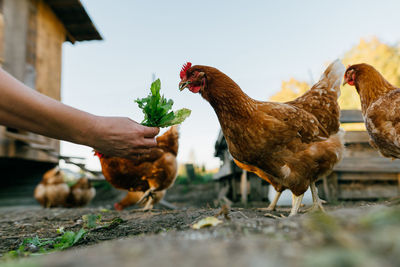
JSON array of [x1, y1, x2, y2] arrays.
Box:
[[0, 0, 66, 162]]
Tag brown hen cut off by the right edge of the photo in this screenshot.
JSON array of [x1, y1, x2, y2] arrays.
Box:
[[343, 63, 400, 158]]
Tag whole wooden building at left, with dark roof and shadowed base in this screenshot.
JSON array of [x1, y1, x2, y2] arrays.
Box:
[[0, 0, 102, 205]]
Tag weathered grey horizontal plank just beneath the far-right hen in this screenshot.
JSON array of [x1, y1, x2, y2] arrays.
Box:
[[334, 157, 400, 173]]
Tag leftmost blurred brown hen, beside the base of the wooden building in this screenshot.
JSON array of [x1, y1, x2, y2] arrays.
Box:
[[33, 167, 70, 208]]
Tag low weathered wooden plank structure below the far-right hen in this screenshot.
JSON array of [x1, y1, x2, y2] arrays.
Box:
[[317, 110, 400, 201]]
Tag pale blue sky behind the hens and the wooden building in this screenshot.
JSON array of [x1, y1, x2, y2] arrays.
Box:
[[61, 0, 400, 172]]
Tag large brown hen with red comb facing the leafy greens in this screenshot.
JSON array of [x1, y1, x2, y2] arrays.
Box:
[[179, 60, 345, 215]]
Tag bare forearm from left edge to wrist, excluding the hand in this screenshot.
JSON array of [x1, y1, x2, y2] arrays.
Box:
[[0, 70, 96, 148]]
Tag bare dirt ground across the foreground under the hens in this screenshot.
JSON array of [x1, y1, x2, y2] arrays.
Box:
[[0, 186, 400, 267]]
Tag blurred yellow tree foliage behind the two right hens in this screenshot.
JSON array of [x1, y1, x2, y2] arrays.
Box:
[[270, 37, 400, 130]]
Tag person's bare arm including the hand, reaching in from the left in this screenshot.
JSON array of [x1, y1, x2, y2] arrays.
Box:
[[0, 69, 159, 157]]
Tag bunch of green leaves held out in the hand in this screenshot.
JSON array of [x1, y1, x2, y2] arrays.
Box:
[[135, 79, 191, 127]]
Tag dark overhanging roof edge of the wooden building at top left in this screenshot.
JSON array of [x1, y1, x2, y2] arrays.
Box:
[[44, 0, 103, 43]]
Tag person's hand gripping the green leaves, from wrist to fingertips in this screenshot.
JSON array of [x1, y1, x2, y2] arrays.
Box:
[[90, 116, 160, 158]]
